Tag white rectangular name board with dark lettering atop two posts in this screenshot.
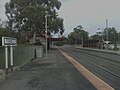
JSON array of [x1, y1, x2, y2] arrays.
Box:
[[2, 37, 17, 46]]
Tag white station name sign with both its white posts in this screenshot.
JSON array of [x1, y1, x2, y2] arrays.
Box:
[[2, 37, 17, 75]]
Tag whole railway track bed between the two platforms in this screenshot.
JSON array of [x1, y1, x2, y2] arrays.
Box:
[[61, 47, 120, 90]]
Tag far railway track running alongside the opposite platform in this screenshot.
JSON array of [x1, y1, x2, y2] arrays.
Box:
[[75, 50, 120, 76]]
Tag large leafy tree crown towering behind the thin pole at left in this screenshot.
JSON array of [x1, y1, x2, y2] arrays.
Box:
[[5, 0, 64, 34]]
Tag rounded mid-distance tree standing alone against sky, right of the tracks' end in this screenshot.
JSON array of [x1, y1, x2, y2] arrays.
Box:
[[68, 25, 89, 44]]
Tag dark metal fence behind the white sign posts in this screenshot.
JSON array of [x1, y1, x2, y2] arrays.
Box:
[[0, 45, 42, 69]]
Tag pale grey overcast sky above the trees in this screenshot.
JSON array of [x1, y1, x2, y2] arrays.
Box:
[[0, 0, 120, 36]]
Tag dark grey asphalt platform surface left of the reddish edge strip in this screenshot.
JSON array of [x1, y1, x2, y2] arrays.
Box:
[[0, 49, 96, 90]]
